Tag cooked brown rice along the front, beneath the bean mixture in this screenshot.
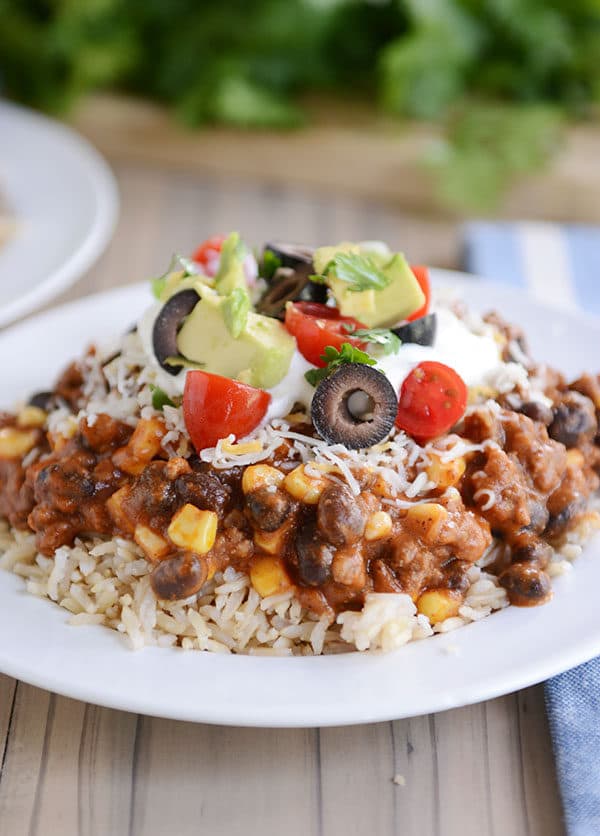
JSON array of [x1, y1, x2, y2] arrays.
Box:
[[0, 520, 508, 656]]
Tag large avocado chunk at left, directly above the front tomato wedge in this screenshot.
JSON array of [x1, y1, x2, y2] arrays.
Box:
[[177, 289, 296, 389]]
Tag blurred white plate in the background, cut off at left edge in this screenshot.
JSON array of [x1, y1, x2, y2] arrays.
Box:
[[0, 102, 118, 327]]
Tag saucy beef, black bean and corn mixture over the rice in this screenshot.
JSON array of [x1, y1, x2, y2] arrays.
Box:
[[0, 352, 600, 618]]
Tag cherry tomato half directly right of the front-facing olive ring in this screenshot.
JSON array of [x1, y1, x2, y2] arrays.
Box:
[[396, 360, 468, 448]]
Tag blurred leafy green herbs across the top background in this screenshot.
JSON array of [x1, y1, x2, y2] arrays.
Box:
[[0, 0, 600, 210]]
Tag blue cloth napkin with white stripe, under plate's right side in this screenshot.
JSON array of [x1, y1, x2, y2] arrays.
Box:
[[464, 222, 600, 836]]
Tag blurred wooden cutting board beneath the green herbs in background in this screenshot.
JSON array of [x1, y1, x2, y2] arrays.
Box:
[[72, 94, 600, 223]]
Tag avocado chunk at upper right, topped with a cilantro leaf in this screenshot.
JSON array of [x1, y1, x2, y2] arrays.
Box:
[[327, 253, 425, 328]]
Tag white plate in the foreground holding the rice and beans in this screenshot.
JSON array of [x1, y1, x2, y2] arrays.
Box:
[[0, 271, 600, 726]]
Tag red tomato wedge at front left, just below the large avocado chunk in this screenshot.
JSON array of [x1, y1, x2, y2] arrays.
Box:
[[183, 370, 271, 451]]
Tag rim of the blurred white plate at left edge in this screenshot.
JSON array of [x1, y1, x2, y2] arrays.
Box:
[[0, 101, 120, 328]]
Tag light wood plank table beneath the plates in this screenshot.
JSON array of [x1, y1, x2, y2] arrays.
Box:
[[0, 163, 563, 836]]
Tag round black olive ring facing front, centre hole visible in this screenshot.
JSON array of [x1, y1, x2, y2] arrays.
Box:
[[311, 363, 398, 450]]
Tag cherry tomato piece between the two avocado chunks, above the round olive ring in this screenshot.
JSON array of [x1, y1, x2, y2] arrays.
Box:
[[285, 302, 366, 368]]
